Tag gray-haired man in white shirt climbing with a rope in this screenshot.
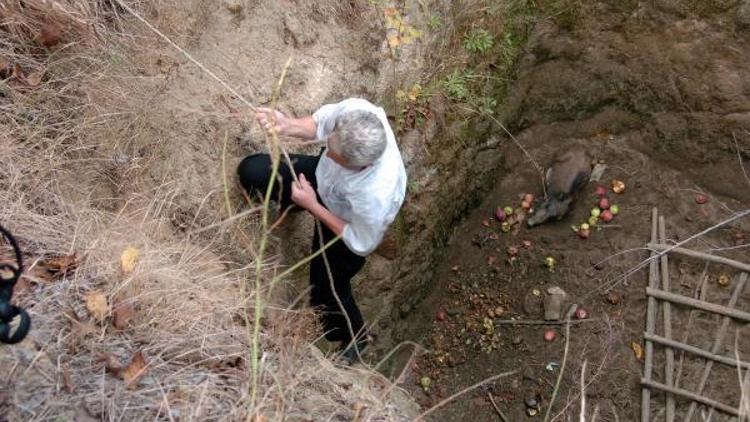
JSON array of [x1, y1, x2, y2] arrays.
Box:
[[238, 98, 406, 364]]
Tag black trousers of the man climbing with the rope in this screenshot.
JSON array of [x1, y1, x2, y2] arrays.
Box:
[[237, 154, 365, 345]]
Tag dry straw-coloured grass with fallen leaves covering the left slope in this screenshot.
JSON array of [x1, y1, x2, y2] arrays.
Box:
[[0, 0, 418, 421]]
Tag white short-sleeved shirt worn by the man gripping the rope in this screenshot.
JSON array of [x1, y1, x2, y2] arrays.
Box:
[[313, 98, 406, 256]]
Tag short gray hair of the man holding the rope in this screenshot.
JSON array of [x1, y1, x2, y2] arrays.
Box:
[[330, 110, 388, 166]]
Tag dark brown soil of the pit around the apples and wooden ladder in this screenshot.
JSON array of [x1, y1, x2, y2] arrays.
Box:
[[396, 2, 750, 421]]
